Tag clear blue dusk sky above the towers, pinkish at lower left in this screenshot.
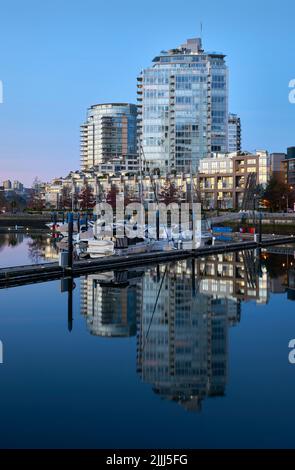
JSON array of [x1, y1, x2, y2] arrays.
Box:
[[0, 0, 295, 186]]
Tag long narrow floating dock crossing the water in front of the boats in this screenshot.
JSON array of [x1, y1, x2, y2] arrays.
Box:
[[0, 237, 295, 288]]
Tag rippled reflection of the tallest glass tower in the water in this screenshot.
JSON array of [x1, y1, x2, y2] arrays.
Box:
[[137, 261, 239, 410]]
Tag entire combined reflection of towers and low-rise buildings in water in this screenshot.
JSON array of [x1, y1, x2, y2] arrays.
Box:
[[81, 251, 295, 411]]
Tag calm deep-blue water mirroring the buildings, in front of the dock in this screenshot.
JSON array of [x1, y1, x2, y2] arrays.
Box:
[[0, 235, 295, 448]]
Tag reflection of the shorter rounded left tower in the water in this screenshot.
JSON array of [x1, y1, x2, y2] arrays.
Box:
[[81, 273, 140, 337]]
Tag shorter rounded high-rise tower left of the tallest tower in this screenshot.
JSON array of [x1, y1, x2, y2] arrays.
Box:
[[81, 103, 138, 172]]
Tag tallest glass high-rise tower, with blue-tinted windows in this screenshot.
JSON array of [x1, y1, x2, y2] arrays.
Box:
[[138, 38, 228, 172]]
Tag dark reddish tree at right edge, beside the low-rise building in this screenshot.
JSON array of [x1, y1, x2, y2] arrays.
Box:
[[263, 176, 293, 211]]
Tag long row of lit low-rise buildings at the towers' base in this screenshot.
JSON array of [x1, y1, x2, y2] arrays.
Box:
[[45, 151, 270, 209]]
